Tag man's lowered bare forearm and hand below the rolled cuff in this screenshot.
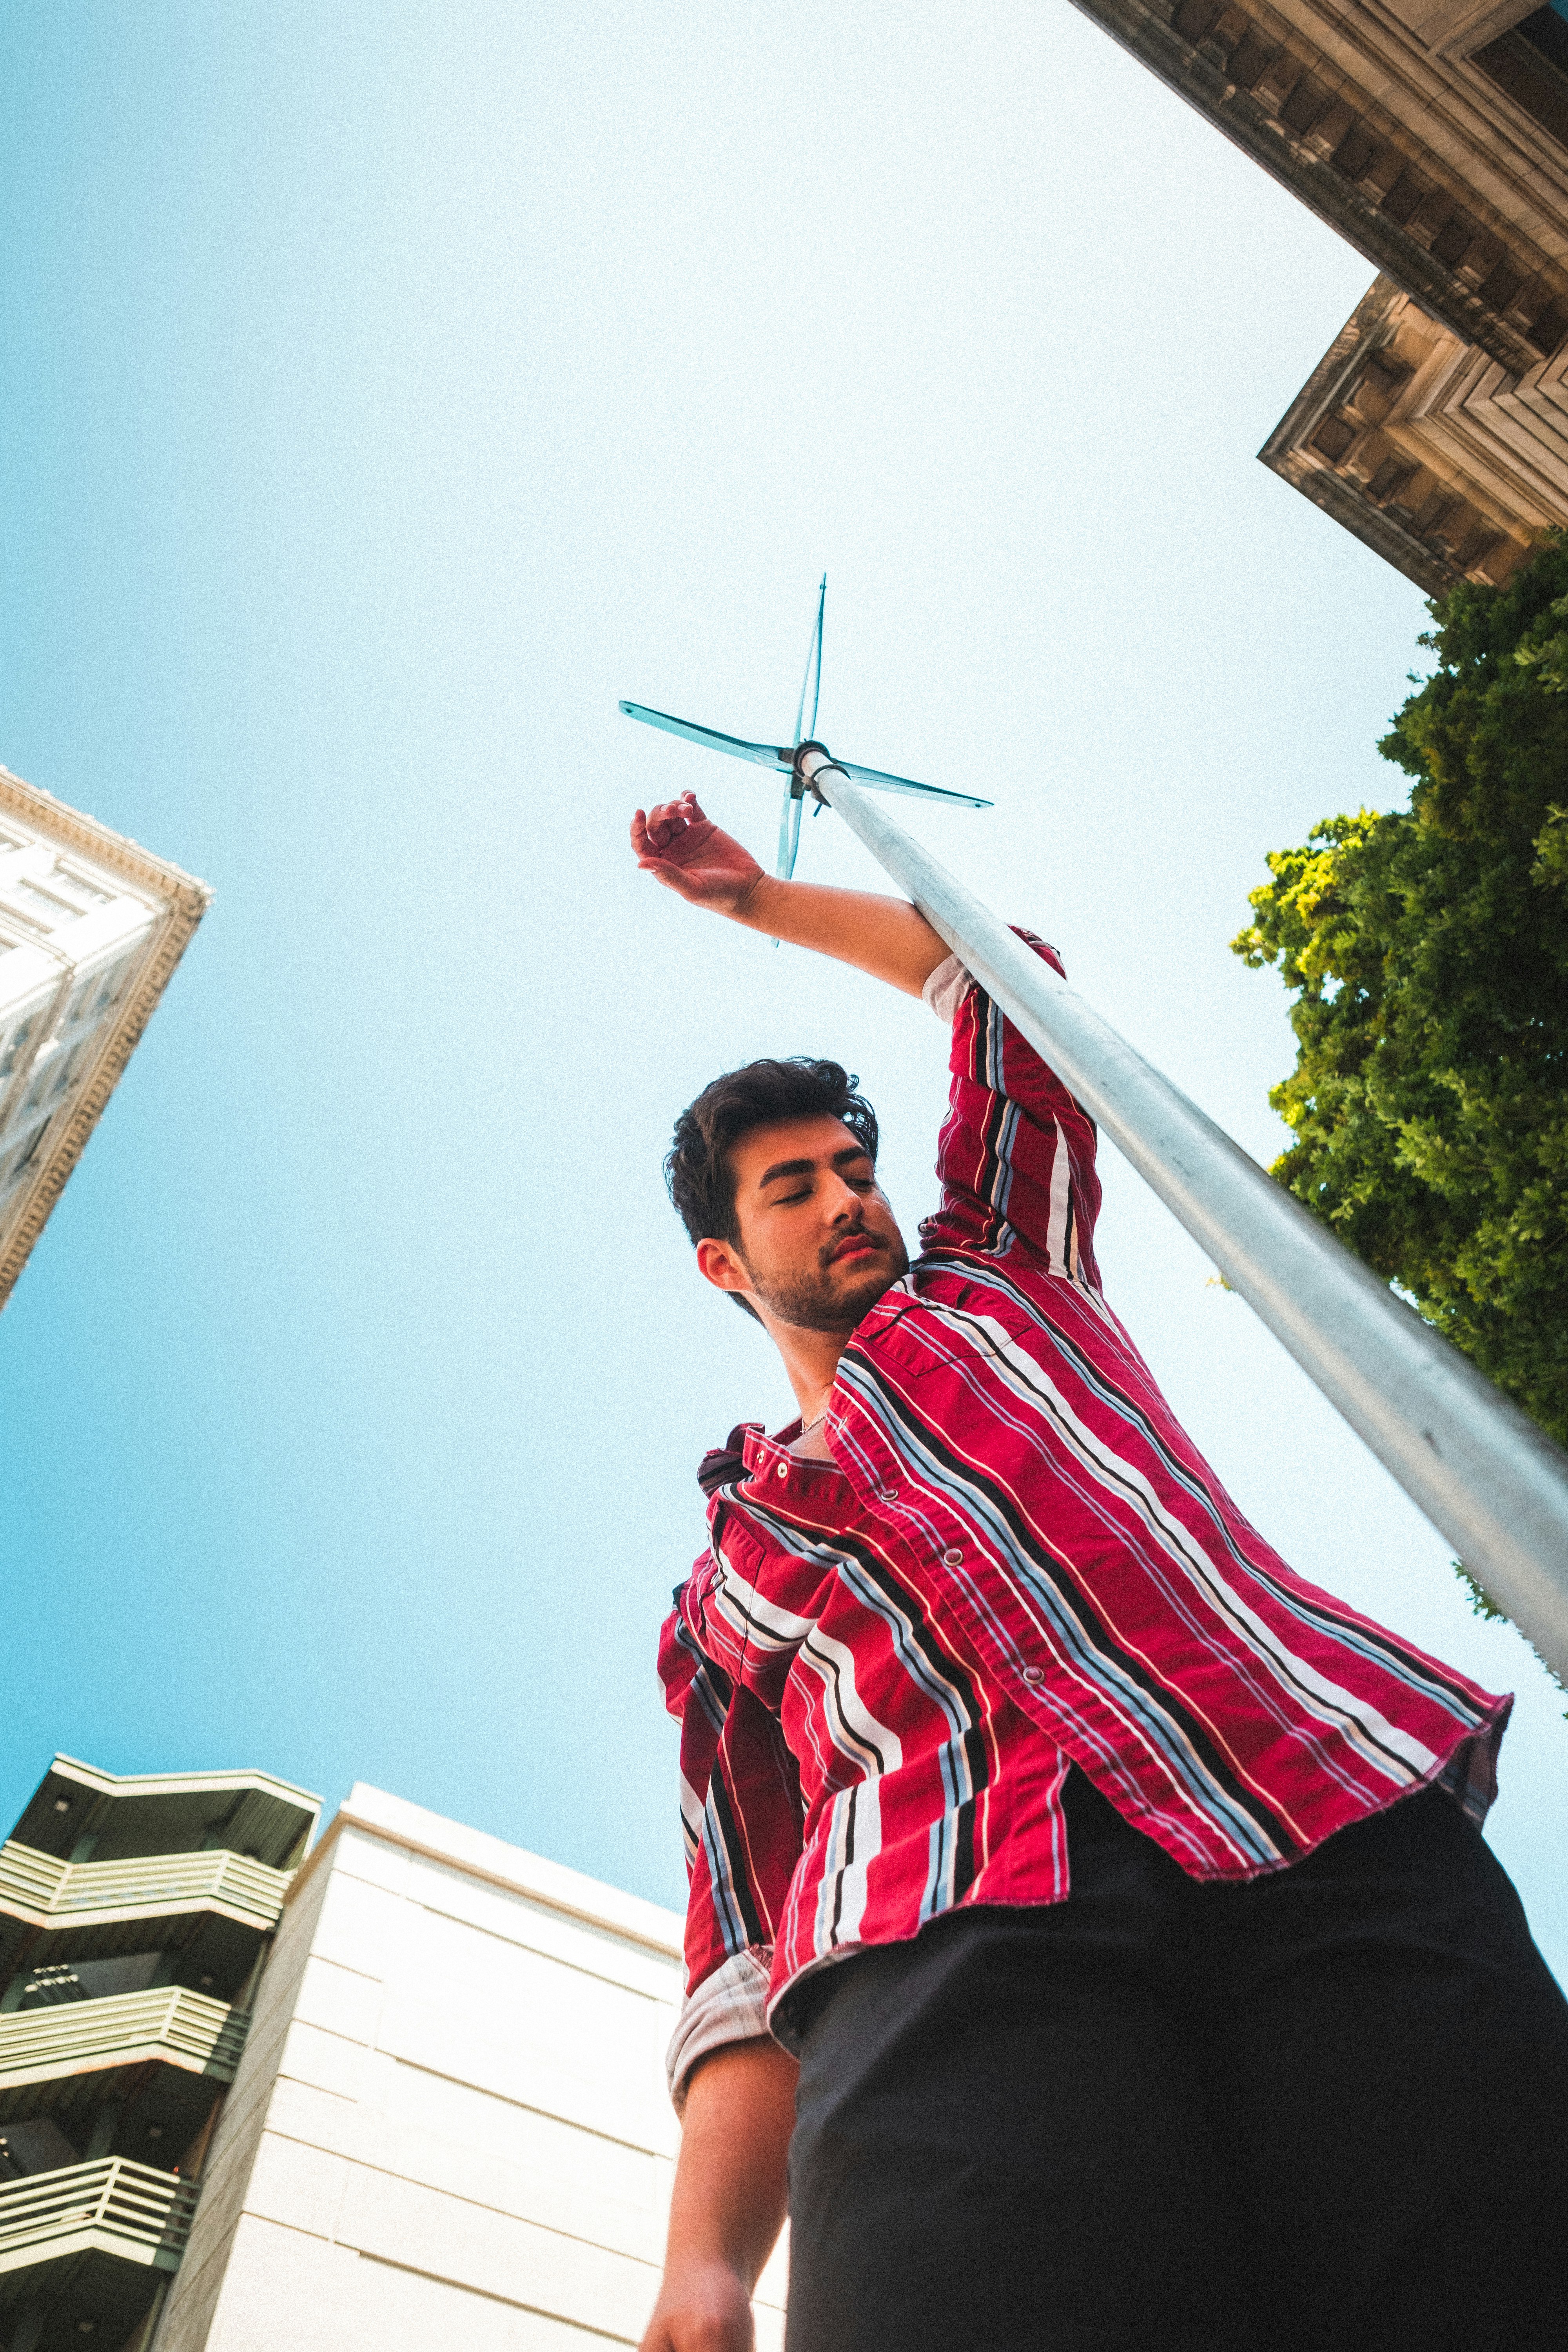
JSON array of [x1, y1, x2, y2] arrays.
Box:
[[642, 2042, 797, 2352]]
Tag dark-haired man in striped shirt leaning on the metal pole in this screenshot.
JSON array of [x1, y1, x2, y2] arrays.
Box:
[[632, 795, 1568, 2352]]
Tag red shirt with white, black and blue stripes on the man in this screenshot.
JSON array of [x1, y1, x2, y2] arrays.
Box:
[[661, 934, 1509, 2098]]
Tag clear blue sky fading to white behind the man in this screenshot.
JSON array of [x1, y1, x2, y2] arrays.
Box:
[[0, 0, 1568, 1971]]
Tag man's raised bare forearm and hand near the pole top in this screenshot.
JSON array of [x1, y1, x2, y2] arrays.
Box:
[[632, 793, 947, 997]]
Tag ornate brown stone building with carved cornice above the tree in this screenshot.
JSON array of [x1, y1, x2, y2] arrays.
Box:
[[1077, 0, 1568, 593]]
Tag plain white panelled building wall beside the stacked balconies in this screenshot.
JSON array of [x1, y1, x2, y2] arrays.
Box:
[[155, 1785, 783, 2352]]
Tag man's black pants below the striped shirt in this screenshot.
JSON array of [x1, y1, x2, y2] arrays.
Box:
[[788, 1771, 1568, 2352]]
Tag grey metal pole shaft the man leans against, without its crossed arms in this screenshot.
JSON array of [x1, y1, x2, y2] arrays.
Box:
[[799, 746, 1568, 1679]]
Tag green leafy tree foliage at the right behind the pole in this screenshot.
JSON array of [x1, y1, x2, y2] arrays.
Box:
[[1232, 539, 1568, 1442]]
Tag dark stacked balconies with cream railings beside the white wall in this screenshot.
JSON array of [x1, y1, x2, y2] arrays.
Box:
[[0, 1757, 318, 2352]]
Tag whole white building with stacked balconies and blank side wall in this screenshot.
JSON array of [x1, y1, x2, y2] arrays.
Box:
[[0, 1757, 788, 2352]]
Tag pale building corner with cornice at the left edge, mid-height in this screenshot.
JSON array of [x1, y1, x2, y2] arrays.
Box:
[[0, 769, 212, 1305]]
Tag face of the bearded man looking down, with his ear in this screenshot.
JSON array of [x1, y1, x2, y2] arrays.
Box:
[[698, 1117, 910, 1334]]
